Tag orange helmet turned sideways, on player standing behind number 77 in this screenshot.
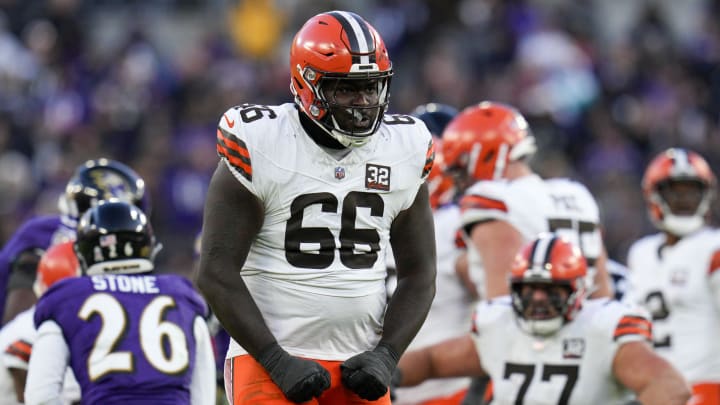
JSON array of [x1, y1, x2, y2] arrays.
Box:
[[442, 101, 536, 181]]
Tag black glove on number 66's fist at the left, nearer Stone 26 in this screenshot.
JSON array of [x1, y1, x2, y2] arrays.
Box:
[[257, 343, 330, 403]]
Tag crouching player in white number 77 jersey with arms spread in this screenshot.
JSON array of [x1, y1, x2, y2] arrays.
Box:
[[398, 233, 690, 405]]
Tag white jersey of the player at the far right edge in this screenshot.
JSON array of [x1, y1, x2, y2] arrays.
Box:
[[624, 228, 720, 383]]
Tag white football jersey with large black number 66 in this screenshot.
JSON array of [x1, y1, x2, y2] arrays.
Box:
[[217, 104, 434, 360]]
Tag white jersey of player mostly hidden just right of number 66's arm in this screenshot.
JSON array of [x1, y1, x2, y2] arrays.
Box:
[[393, 205, 472, 405]]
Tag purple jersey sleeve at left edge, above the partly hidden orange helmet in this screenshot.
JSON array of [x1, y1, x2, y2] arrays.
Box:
[[0, 215, 60, 318]]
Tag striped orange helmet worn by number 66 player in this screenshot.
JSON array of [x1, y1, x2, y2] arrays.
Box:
[[290, 11, 393, 147]]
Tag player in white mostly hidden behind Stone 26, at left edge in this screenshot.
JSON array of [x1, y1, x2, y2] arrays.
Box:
[[0, 242, 80, 405]]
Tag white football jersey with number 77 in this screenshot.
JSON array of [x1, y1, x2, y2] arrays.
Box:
[[473, 296, 651, 405]]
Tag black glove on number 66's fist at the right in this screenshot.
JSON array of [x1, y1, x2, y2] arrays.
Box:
[[340, 343, 400, 401]]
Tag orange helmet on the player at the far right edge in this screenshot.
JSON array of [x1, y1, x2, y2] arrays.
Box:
[[642, 148, 716, 236]]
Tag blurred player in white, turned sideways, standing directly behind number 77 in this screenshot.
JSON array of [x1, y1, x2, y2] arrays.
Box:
[[442, 101, 611, 299]]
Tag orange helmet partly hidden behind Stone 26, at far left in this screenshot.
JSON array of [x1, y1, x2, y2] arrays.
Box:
[[33, 242, 80, 297]]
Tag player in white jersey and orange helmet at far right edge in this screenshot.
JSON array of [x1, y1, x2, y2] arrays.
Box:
[[626, 148, 720, 405]]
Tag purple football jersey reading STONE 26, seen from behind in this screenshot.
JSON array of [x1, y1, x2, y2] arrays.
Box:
[[35, 274, 207, 405]]
